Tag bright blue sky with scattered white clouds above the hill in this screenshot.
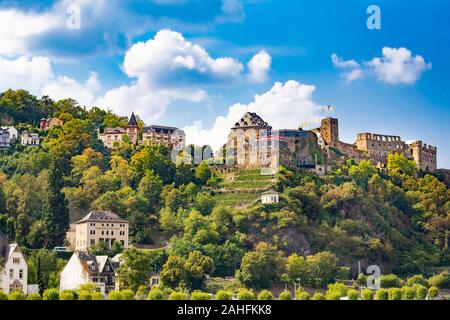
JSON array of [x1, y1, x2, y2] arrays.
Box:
[[0, 0, 450, 167]]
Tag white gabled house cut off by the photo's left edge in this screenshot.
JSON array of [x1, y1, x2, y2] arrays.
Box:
[[0, 242, 28, 294]]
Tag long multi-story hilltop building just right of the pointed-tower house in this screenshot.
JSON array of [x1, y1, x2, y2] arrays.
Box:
[[142, 125, 186, 151]]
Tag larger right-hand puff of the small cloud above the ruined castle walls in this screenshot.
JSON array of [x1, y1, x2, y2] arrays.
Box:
[[367, 47, 432, 84]]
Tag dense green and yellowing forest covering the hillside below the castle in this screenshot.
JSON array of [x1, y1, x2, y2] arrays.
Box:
[[0, 90, 450, 298]]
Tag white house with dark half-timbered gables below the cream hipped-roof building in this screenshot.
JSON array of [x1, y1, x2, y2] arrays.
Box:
[[59, 251, 118, 296]]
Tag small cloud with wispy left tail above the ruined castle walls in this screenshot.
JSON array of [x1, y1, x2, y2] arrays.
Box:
[[331, 47, 432, 84]]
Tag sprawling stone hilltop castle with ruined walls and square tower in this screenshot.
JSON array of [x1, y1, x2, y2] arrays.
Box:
[[227, 112, 437, 171]]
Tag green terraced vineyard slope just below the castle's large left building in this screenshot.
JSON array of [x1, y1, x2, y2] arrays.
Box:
[[214, 170, 275, 208]]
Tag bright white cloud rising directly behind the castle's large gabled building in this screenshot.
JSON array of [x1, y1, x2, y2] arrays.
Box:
[[183, 80, 322, 150]]
